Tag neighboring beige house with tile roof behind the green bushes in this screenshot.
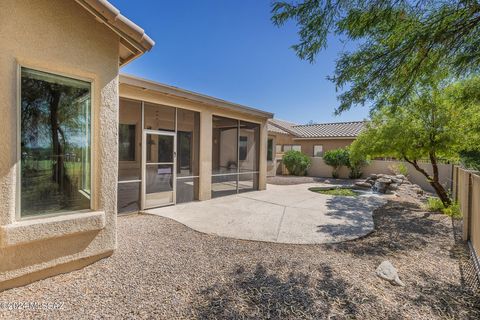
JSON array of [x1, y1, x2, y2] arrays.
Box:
[[267, 119, 366, 176]]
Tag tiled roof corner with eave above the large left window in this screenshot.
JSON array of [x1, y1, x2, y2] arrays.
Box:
[[75, 0, 155, 66]]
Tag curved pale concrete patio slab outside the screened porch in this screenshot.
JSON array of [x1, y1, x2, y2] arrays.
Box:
[[146, 183, 386, 244]]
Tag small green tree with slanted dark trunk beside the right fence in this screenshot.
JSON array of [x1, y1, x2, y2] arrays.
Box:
[[350, 78, 480, 207]]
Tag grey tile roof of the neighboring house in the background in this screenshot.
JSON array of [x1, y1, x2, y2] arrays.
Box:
[[269, 119, 366, 138]]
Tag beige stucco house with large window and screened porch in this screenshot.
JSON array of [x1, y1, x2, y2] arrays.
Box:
[[0, 0, 273, 290]]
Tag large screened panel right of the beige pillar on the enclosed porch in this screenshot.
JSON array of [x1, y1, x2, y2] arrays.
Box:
[[212, 116, 260, 197]]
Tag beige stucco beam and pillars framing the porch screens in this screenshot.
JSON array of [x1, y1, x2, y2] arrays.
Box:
[[120, 83, 268, 200]]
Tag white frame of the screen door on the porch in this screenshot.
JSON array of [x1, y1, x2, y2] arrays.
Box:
[[141, 129, 177, 210]]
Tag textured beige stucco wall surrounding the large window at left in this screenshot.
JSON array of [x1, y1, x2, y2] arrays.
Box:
[[0, 0, 119, 290]]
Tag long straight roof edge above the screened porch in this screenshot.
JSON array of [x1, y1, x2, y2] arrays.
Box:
[[120, 74, 273, 119]]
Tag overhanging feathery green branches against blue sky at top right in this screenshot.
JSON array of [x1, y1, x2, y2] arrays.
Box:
[[272, 0, 480, 113]]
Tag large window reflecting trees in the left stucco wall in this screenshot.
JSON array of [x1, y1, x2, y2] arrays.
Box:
[[20, 68, 91, 217]]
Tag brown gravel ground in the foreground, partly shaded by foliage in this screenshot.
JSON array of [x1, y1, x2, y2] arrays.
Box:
[[0, 189, 480, 319]]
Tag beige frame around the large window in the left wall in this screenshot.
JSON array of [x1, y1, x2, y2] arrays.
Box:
[[15, 62, 97, 221]]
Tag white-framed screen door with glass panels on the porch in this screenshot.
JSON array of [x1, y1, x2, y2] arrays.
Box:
[[142, 130, 177, 209]]
